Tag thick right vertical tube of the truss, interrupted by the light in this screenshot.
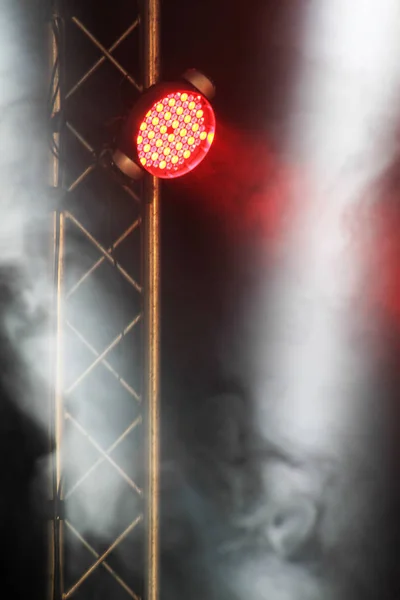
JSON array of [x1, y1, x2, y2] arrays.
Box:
[[143, 0, 160, 600]]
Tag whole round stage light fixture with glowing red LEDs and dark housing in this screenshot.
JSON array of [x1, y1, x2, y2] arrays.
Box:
[[113, 70, 215, 179]]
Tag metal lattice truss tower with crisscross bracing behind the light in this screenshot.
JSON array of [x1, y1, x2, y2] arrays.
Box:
[[49, 0, 160, 600]]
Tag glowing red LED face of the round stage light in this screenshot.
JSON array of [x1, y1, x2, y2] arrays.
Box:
[[135, 91, 215, 179]]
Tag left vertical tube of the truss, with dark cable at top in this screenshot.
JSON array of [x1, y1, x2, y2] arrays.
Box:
[[49, 0, 64, 600]]
